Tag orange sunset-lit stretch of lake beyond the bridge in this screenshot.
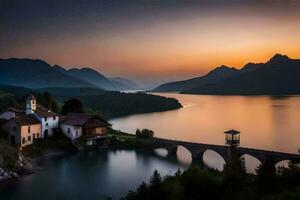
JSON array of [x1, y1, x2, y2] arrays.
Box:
[[110, 93, 300, 153]]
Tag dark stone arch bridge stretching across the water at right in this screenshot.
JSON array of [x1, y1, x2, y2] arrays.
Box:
[[153, 138, 300, 164]]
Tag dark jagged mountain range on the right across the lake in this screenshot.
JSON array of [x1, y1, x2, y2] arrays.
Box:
[[153, 54, 300, 95]]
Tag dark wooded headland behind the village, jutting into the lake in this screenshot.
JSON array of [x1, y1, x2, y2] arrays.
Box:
[[0, 86, 182, 119]]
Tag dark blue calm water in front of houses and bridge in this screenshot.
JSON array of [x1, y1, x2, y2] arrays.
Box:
[[0, 150, 187, 200]]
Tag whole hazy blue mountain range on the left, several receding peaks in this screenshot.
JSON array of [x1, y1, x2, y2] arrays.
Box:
[[0, 58, 139, 90]]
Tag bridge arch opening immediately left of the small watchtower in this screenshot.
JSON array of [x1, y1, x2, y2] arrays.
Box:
[[202, 149, 226, 171]]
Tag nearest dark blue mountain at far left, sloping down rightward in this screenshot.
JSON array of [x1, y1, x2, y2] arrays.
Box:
[[0, 58, 96, 88]]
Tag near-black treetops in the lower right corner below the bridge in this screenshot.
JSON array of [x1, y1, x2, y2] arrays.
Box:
[[122, 152, 300, 200]]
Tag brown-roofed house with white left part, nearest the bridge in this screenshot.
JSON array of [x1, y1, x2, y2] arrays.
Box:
[[61, 113, 109, 142]]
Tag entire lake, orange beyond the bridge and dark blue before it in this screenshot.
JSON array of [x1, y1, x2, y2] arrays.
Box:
[[0, 93, 300, 200]]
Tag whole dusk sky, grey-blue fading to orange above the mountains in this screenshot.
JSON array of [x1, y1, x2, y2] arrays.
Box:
[[0, 0, 300, 83]]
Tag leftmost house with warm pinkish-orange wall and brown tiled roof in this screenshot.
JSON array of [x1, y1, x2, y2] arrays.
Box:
[[2, 113, 42, 148]]
